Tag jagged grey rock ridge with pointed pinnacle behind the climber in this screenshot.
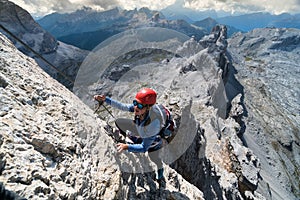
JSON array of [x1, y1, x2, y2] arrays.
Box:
[[74, 22, 268, 199]]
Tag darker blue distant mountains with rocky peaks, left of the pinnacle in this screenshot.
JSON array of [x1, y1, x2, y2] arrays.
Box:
[[38, 7, 208, 50]]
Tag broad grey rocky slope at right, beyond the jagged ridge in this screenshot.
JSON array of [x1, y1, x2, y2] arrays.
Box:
[[228, 28, 300, 199]]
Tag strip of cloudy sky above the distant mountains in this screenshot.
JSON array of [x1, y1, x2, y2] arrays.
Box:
[[10, 0, 300, 17]]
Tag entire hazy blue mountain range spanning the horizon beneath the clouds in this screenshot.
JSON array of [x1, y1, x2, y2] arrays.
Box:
[[37, 4, 300, 50]]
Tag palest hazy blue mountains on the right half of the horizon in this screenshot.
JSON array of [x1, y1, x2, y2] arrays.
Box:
[[161, 0, 300, 32]]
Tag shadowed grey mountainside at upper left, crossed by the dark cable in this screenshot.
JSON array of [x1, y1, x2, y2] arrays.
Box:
[[0, 0, 87, 88]]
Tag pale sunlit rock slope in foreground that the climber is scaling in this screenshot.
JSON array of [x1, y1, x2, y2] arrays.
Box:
[[0, 34, 203, 199]]
